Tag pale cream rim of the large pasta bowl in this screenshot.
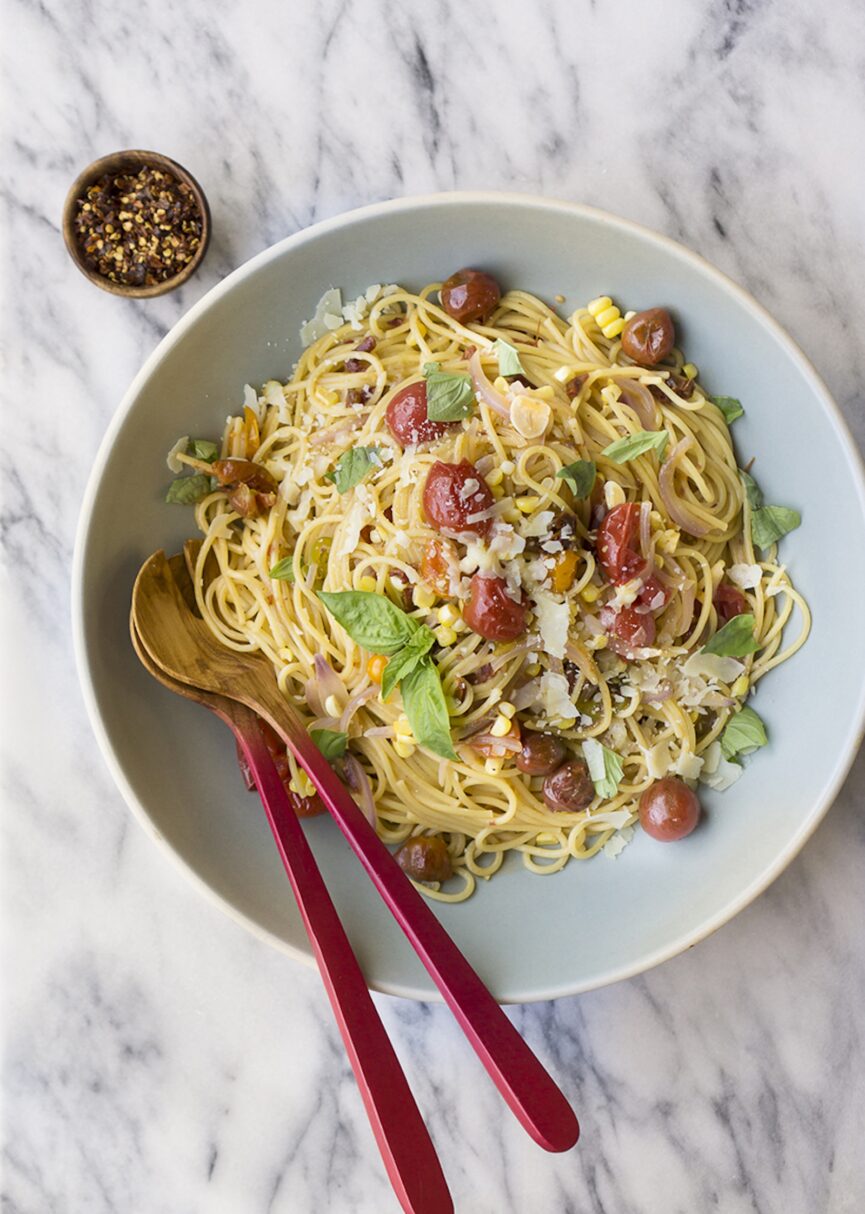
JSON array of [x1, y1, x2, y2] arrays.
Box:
[[72, 191, 865, 1003]]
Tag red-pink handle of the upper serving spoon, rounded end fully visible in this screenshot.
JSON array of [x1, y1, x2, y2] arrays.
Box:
[[271, 717, 580, 1151]]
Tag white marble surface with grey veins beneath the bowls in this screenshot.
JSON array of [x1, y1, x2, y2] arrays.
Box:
[[0, 0, 865, 1214]]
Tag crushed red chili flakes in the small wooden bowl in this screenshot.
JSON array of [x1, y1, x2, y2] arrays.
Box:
[[75, 166, 204, 287]]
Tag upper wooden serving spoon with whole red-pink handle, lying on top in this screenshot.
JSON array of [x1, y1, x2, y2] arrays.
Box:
[[132, 551, 580, 1151]]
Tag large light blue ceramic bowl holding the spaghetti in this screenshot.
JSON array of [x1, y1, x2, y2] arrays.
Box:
[[74, 194, 865, 1002]]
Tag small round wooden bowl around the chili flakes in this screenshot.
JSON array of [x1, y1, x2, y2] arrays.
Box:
[[63, 149, 211, 300]]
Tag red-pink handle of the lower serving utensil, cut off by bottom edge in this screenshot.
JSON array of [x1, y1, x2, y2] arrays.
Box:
[[232, 705, 454, 1214]]
